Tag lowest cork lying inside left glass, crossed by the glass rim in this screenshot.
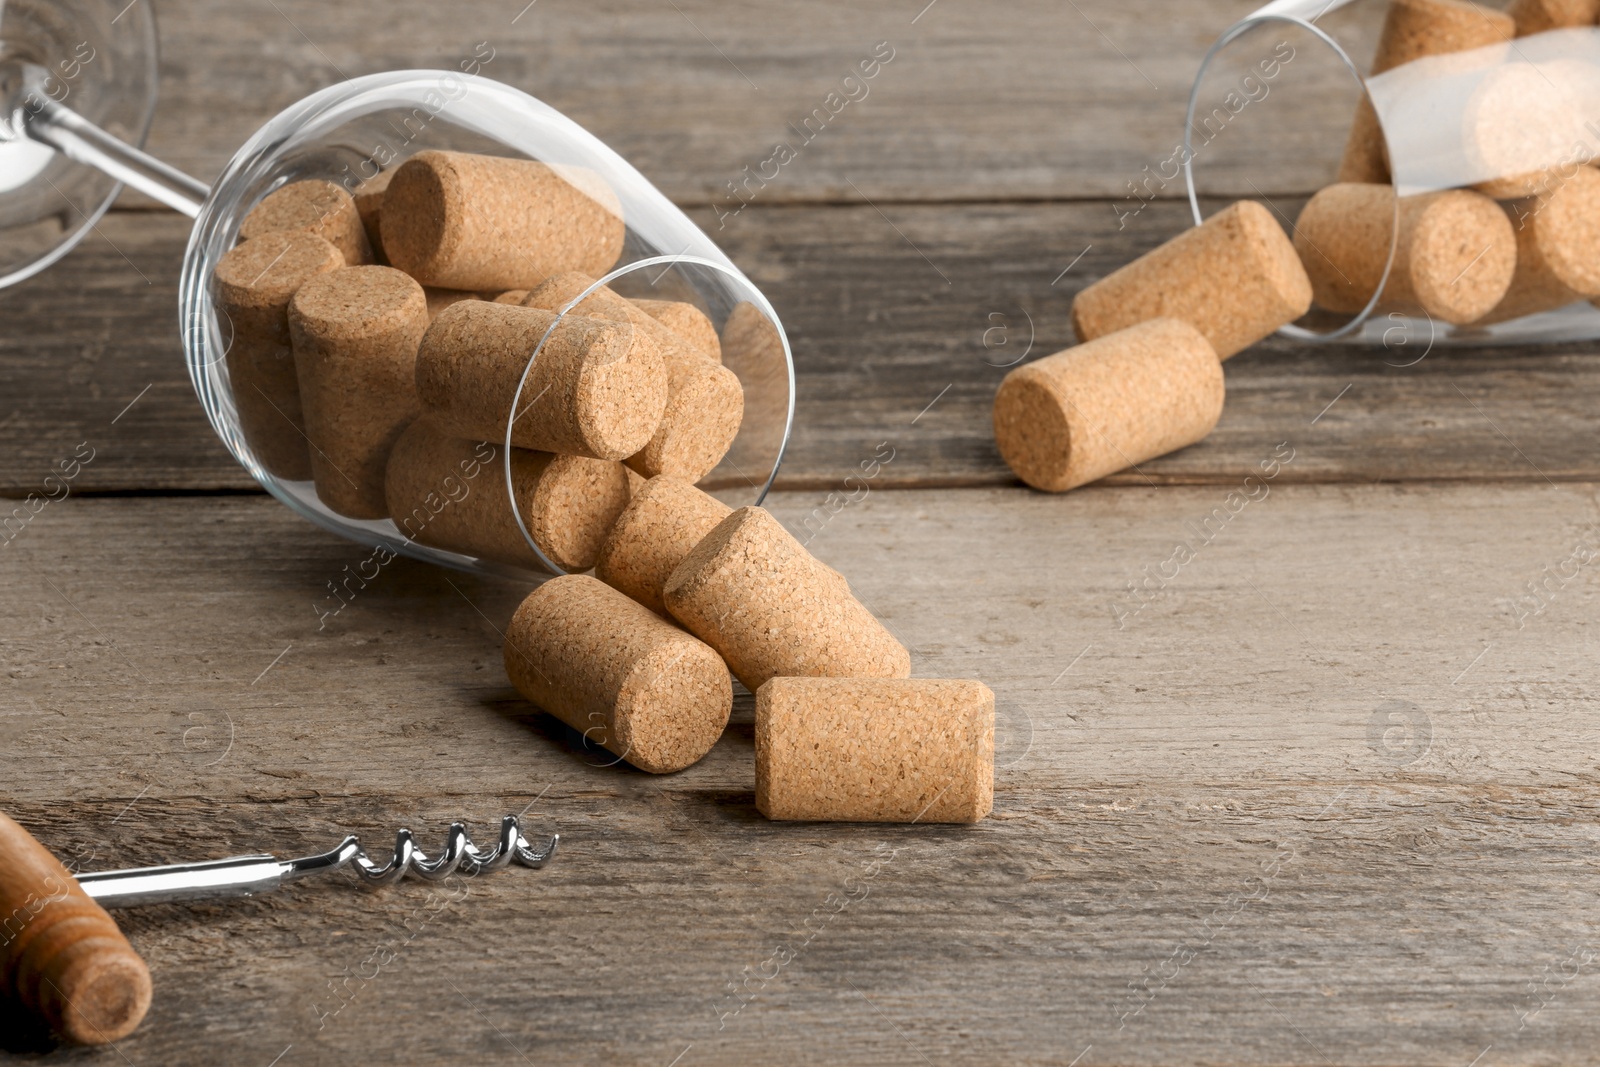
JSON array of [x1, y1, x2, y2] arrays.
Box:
[[384, 416, 627, 571]]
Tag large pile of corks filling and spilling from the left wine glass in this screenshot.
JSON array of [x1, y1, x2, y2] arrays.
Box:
[[214, 150, 994, 822]]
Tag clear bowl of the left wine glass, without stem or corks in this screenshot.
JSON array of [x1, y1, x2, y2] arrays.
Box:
[[179, 70, 794, 577]]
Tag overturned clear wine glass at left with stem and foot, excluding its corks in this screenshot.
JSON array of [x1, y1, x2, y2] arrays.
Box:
[[0, 0, 794, 577]]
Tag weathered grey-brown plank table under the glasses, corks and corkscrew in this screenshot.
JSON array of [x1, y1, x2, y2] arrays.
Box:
[[0, 0, 1600, 1067]]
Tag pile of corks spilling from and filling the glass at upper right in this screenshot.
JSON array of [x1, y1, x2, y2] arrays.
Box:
[[994, 0, 1600, 493]]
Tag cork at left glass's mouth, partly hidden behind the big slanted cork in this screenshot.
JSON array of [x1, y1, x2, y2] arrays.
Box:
[[595, 475, 733, 614]]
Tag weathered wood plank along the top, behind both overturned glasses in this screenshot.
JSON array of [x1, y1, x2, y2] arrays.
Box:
[[128, 0, 1381, 203]]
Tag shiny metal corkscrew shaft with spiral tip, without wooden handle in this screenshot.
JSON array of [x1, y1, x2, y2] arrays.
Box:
[[77, 816, 560, 907]]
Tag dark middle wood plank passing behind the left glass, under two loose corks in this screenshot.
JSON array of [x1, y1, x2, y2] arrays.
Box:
[[0, 202, 1600, 496]]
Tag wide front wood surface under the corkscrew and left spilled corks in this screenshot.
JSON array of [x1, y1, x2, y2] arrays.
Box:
[[0, 486, 1600, 1064]]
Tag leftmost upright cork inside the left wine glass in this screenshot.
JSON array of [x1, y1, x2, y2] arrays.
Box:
[[216, 234, 344, 482]]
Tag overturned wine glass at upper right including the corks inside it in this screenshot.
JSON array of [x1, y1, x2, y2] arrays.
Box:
[[1184, 0, 1600, 347]]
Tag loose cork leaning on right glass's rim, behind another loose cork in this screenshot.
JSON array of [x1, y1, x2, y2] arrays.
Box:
[[1072, 200, 1310, 360]]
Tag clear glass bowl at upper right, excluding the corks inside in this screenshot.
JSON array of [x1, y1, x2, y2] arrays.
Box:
[[1184, 0, 1600, 347]]
